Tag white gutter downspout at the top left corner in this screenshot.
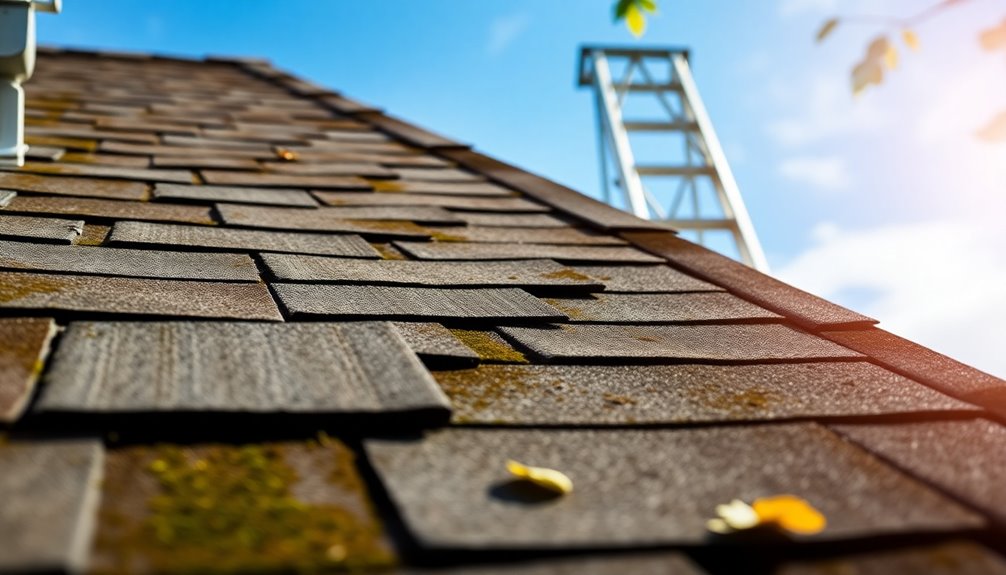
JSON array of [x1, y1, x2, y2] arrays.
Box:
[[0, 0, 62, 166]]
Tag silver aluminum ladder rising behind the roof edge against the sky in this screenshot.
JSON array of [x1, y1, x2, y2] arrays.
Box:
[[577, 46, 769, 272]]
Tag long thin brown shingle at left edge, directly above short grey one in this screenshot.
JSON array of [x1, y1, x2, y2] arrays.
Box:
[[5, 196, 215, 225]]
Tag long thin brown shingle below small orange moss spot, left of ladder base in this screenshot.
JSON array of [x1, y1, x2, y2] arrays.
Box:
[[314, 191, 551, 213]]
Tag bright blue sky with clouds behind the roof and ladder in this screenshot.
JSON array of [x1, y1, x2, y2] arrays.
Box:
[[38, 0, 1006, 376]]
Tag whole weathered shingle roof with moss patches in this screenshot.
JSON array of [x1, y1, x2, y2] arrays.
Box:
[[0, 50, 1006, 574]]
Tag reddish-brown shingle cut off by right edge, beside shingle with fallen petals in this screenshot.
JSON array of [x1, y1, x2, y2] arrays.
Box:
[[835, 419, 1006, 526]]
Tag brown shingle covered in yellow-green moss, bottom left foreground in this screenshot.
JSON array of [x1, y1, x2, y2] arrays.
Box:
[[93, 438, 394, 572]]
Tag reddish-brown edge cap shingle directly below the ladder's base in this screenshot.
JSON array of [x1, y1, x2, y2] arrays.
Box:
[[623, 232, 876, 328]]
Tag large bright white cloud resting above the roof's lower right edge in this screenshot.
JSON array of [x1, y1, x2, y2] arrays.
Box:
[[777, 220, 1006, 377]]
